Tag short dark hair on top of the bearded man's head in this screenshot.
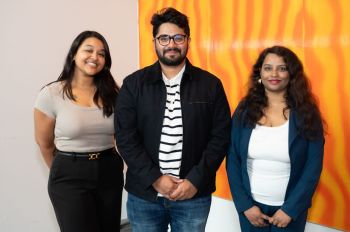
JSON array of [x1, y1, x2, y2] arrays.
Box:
[[151, 7, 190, 38]]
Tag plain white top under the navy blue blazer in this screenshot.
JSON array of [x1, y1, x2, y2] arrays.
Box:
[[247, 121, 290, 206]]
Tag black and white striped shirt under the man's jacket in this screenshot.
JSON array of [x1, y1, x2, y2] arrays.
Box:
[[159, 66, 185, 178]]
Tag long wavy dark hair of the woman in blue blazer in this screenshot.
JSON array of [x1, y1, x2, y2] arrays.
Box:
[[238, 46, 323, 139]]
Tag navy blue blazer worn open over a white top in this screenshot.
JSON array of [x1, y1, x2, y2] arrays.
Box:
[[226, 107, 324, 220]]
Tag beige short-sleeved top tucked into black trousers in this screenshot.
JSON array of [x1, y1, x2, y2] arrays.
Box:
[[34, 82, 114, 152]]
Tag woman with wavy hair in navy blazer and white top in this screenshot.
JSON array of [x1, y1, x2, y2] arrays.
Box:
[[226, 46, 324, 232]]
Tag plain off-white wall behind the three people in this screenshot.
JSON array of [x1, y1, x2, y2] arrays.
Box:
[[0, 0, 344, 232]]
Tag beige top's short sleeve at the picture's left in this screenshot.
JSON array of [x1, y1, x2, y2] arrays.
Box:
[[34, 86, 56, 119]]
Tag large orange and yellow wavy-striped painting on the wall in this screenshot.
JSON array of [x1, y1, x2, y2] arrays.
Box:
[[139, 0, 350, 231]]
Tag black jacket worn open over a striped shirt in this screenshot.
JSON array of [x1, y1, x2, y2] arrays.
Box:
[[114, 60, 231, 201]]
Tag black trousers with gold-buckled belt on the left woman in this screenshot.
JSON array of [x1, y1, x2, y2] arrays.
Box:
[[48, 151, 124, 232]]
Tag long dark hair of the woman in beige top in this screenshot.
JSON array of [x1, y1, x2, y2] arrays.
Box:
[[48, 31, 119, 117]]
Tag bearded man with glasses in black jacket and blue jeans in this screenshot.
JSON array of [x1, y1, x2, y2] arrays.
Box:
[[115, 8, 230, 232]]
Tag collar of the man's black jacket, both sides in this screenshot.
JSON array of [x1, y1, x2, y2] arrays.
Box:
[[145, 58, 193, 83]]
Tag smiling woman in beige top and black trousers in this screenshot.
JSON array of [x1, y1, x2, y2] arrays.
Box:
[[34, 31, 124, 232]]
